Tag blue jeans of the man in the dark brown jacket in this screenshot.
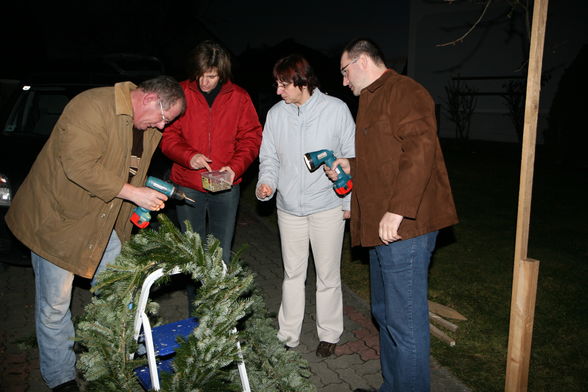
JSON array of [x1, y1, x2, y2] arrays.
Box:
[[370, 231, 437, 392]]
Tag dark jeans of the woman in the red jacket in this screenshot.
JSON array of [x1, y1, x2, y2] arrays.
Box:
[[176, 185, 240, 263]]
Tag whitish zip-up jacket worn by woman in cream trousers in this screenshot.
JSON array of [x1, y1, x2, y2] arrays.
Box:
[[256, 88, 355, 216]]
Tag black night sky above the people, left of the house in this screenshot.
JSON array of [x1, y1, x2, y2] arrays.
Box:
[[0, 0, 408, 78]]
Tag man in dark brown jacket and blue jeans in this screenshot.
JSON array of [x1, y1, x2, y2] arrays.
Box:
[[325, 39, 457, 392]]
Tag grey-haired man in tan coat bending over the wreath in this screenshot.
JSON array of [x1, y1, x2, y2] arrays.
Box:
[[6, 76, 185, 392]]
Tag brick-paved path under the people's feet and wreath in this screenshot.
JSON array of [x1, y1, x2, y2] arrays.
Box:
[[0, 205, 469, 392]]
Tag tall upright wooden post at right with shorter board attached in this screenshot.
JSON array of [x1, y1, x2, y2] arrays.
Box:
[[504, 0, 548, 392]]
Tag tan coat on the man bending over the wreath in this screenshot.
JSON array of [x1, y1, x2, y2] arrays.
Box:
[[6, 82, 161, 278]]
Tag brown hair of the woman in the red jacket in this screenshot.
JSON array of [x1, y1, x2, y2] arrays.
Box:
[[188, 40, 231, 83]]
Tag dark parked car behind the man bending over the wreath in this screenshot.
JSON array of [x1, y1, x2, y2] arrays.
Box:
[[0, 56, 171, 264]]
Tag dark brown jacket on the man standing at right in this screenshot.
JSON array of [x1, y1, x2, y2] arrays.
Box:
[[351, 70, 458, 247]]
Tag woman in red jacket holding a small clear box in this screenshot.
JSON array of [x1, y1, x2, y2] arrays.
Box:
[[161, 41, 261, 262]]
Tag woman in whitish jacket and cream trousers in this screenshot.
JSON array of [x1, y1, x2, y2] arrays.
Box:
[[256, 55, 355, 357]]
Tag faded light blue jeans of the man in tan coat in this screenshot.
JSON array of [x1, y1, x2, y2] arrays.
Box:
[[31, 230, 121, 388]]
